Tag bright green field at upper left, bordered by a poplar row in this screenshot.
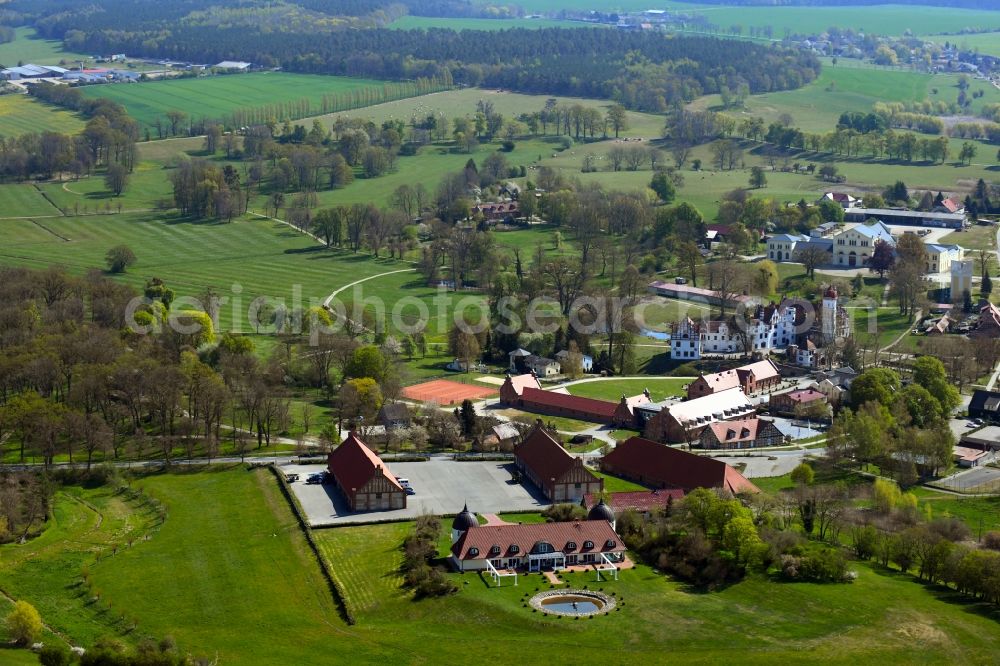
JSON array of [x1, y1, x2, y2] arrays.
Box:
[[84, 72, 396, 126]]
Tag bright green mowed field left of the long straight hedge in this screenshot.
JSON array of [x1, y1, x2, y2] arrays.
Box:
[[87, 466, 349, 664]]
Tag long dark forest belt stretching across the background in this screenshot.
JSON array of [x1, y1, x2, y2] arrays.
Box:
[[40, 18, 820, 112]]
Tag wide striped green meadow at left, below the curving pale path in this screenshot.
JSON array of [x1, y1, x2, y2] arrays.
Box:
[[0, 213, 418, 332]]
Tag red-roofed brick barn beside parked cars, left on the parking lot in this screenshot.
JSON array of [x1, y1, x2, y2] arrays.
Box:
[[326, 432, 406, 511]]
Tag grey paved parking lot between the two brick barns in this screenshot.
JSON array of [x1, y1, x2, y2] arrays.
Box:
[[281, 458, 549, 527]]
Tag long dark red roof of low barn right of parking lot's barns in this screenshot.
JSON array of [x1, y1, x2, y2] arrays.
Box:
[[602, 437, 760, 493]]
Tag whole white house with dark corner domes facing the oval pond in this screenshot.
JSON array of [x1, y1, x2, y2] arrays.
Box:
[[450, 508, 626, 573]]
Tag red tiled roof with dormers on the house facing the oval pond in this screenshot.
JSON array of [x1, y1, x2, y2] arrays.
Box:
[[451, 520, 625, 560]]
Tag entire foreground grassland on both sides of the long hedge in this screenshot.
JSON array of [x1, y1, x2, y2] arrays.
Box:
[[7, 466, 1000, 664]]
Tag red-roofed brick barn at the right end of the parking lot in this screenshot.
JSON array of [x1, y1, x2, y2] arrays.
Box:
[[514, 425, 604, 502]]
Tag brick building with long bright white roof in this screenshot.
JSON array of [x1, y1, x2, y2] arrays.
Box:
[[638, 388, 755, 443]]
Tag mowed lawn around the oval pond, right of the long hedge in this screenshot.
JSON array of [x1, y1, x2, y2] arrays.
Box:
[[316, 515, 1000, 664]]
